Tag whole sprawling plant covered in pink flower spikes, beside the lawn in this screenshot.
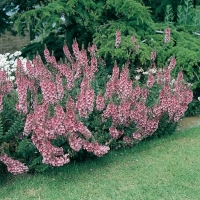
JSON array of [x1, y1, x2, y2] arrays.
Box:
[[0, 28, 193, 173]]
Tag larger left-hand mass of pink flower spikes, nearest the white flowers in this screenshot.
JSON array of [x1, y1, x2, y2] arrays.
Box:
[[13, 41, 109, 170]]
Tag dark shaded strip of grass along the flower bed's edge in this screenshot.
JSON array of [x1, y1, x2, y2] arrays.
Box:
[[1, 127, 200, 186]]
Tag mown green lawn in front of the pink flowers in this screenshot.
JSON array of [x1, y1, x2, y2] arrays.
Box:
[[0, 126, 200, 200]]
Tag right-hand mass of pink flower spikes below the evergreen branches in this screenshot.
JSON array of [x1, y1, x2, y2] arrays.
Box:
[[102, 53, 193, 140]]
